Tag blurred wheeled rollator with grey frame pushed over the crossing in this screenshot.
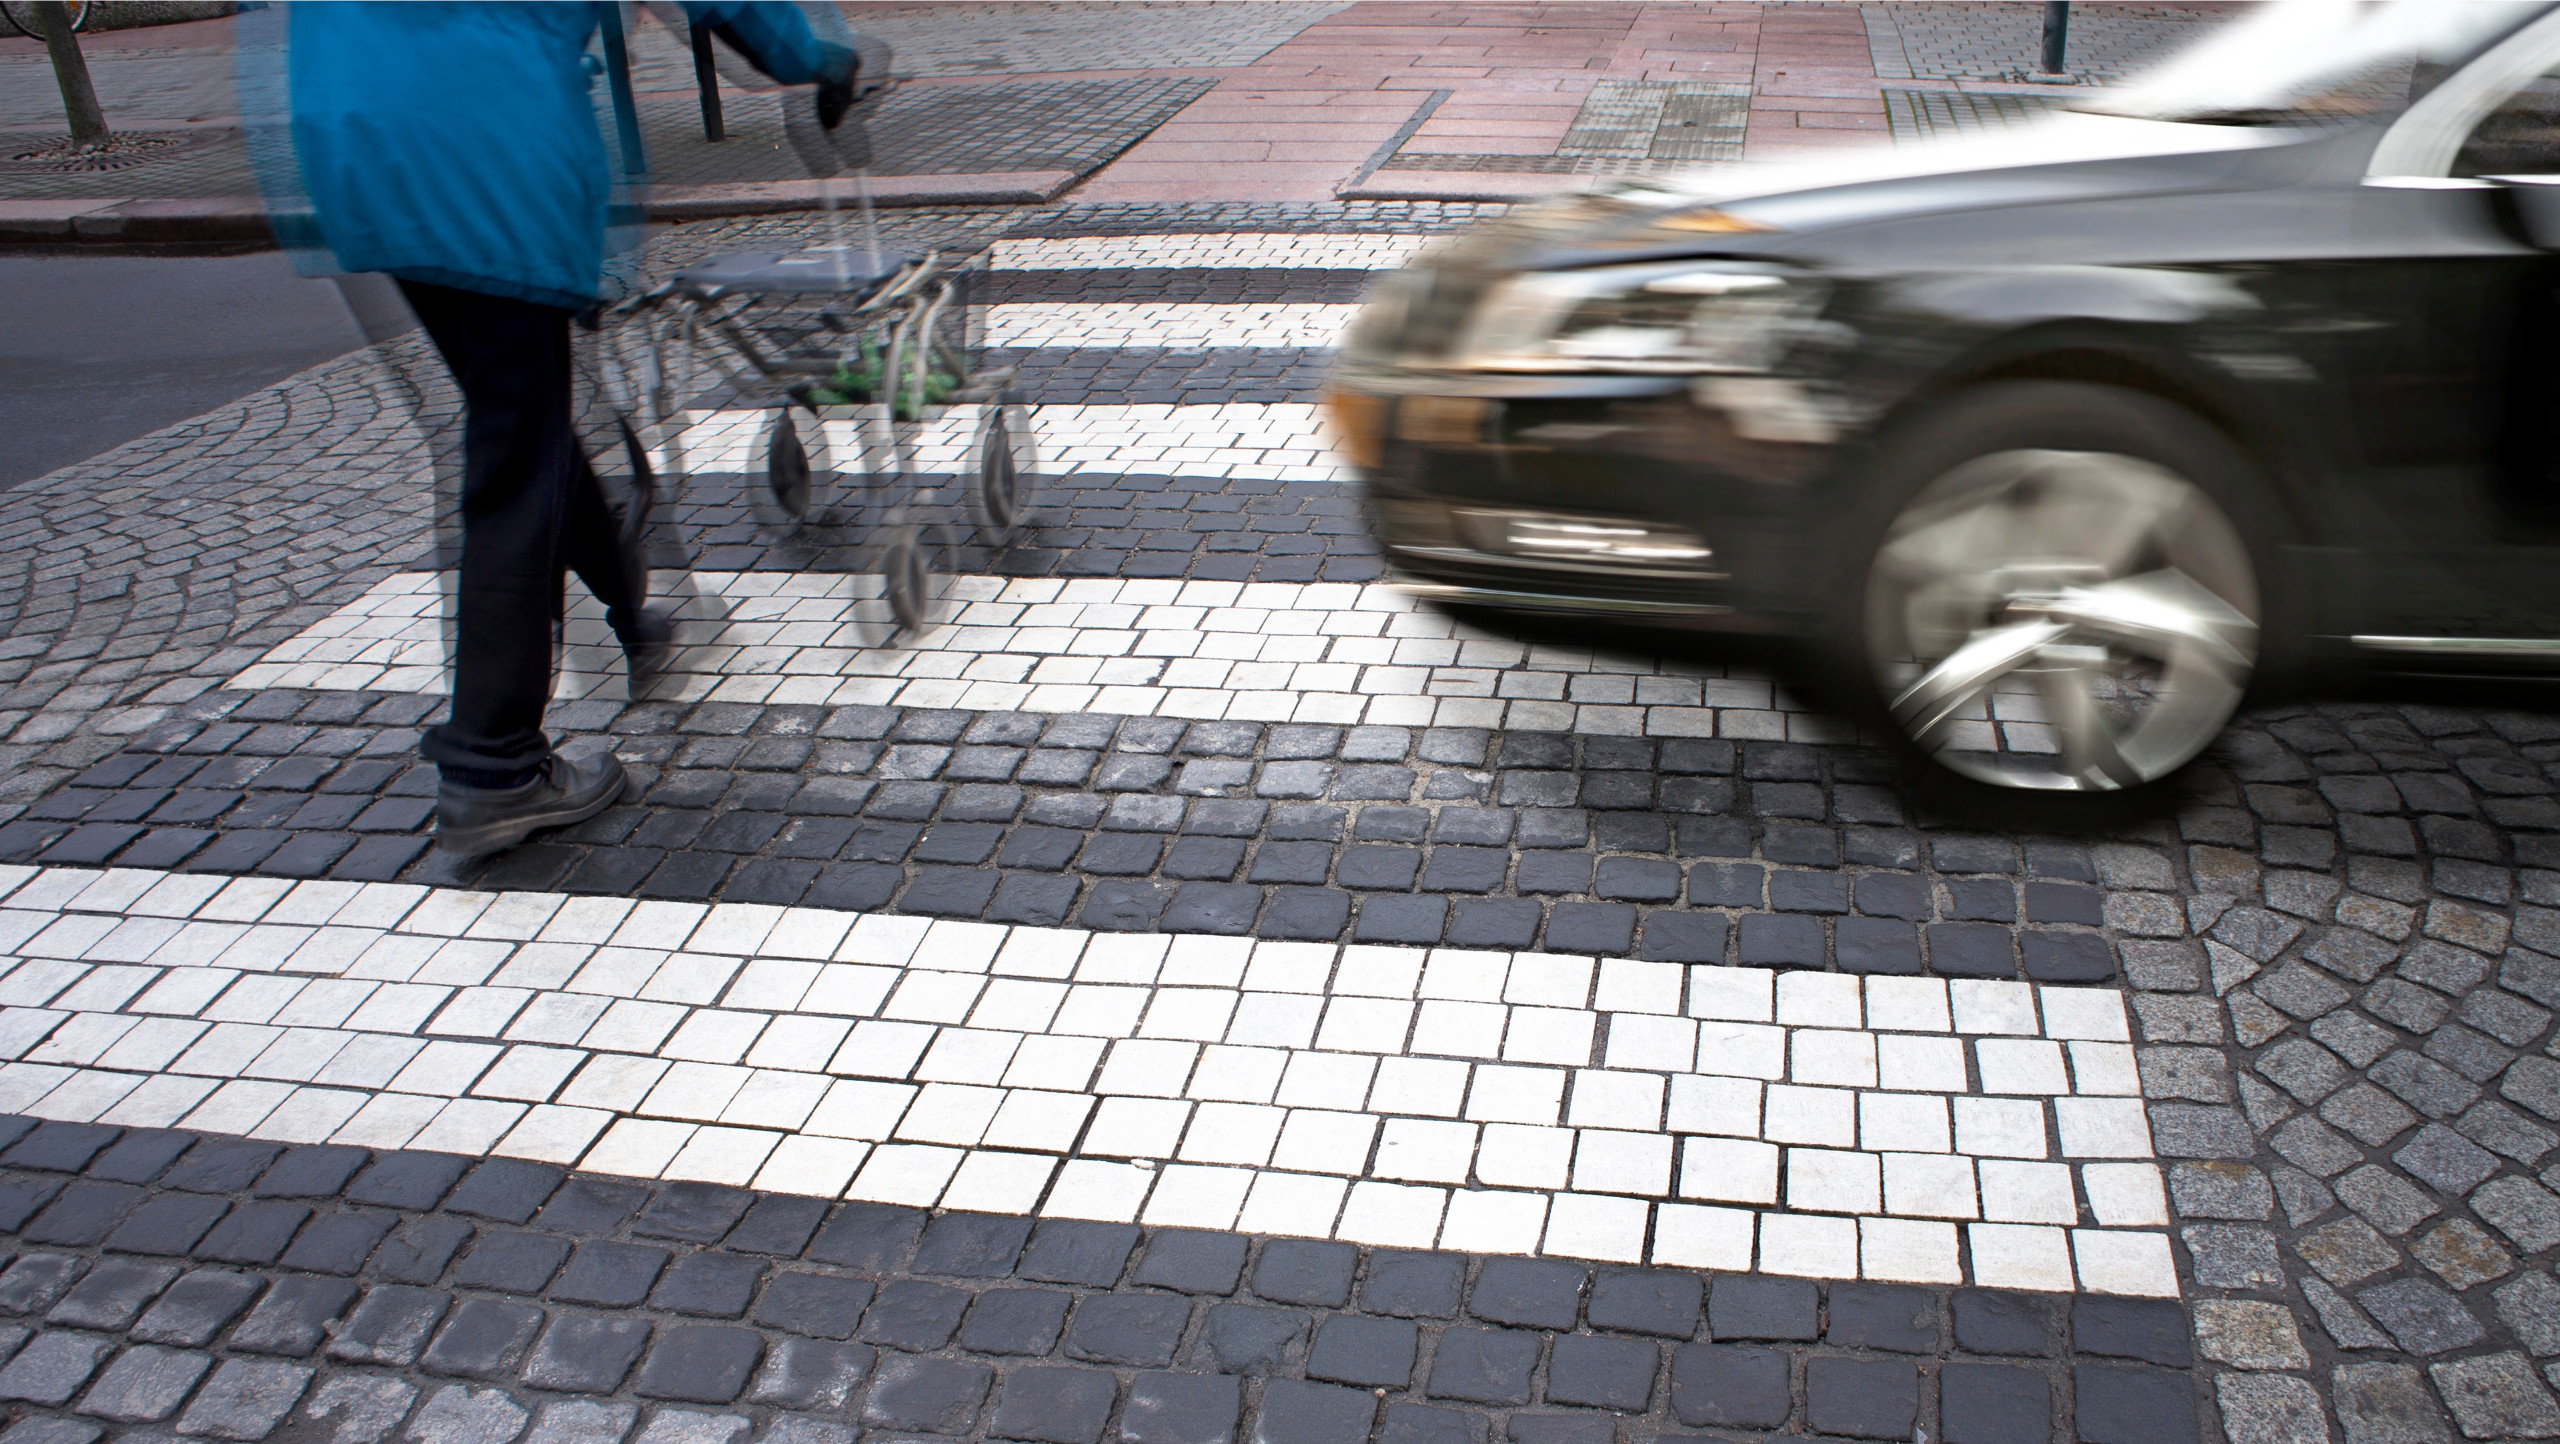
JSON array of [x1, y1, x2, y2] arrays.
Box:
[[596, 12, 1037, 645]]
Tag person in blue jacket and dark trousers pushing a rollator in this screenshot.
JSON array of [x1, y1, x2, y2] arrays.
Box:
[[284, 0, 860, 858]]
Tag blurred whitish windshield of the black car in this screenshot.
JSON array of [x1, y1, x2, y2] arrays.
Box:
[[2071, 0, 2547, 125]]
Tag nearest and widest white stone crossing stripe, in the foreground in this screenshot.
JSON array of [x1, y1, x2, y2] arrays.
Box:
[[0, 868, 2179, 1296]]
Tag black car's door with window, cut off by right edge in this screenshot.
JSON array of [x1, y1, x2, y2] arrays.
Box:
[[2340, 9, 2560, 663]]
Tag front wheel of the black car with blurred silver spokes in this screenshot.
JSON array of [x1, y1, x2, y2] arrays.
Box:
[[1828, 381, 2281, 817]]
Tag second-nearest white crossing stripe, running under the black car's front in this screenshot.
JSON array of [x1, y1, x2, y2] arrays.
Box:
[[228, 571, 1856, 742]]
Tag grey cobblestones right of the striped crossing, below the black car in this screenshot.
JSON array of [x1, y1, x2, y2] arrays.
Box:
[[2081, 704, 2560, 1441]]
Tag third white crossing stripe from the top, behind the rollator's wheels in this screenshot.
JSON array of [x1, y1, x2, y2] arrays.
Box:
[[658, 402, 1357, 481]]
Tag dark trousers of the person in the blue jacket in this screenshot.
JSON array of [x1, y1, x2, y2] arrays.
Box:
[[399, 282, 648, 786]]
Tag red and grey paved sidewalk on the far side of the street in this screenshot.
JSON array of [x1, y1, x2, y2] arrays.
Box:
[[0, 0, 2227, 243]]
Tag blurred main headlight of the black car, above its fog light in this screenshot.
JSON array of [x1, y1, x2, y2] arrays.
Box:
[[1457, 261, 1825, 376]]
